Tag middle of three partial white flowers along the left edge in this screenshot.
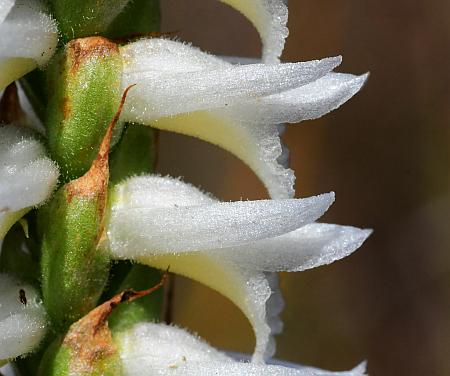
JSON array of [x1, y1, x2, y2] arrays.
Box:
[[0, 126, 59, 240]]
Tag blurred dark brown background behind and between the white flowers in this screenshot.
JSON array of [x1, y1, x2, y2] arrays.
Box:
[[159, 0, 450, 376]]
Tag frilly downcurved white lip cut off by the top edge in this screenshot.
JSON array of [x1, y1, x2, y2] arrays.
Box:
[[221, 0, 289, 64]]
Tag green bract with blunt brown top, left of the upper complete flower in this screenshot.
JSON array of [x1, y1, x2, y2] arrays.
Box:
[[45, 37, 122, 181]]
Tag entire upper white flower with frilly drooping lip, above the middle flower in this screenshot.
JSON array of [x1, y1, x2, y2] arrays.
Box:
[[121, 39, 367, 198]]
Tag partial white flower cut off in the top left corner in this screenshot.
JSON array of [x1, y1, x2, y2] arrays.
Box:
[[0, 0, 58, 90]]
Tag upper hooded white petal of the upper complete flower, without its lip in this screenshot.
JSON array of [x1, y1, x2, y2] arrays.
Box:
[[121, 39, 341, 119]]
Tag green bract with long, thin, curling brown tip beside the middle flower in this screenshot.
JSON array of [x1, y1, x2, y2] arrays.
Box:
[[38, 120, 112, 329]]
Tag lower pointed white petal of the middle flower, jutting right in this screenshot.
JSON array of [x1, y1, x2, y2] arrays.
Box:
[[215, 223, 372, 272]]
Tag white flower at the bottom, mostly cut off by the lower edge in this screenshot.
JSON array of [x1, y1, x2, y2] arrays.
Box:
[[115, 323, 365, 376]]
